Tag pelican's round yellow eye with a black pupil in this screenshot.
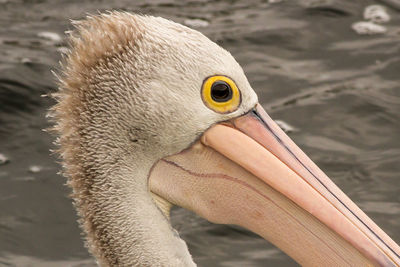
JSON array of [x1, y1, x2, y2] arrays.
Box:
[[201, 75, 241, 113]]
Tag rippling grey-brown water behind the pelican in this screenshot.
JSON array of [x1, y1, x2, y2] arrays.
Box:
[[0, 0, 400, 266]]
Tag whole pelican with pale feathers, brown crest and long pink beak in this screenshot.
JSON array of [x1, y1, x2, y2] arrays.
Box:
[[51, 12, 400, 266]]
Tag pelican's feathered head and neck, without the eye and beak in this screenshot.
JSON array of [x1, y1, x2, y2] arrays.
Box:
[[50, 12, 256, 266]]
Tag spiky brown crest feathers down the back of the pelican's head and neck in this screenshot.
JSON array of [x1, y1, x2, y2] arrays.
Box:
[[48, 12, 145, 261]]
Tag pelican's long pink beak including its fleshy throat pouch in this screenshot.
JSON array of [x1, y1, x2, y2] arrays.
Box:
[[150, 105, 400, 266]]
